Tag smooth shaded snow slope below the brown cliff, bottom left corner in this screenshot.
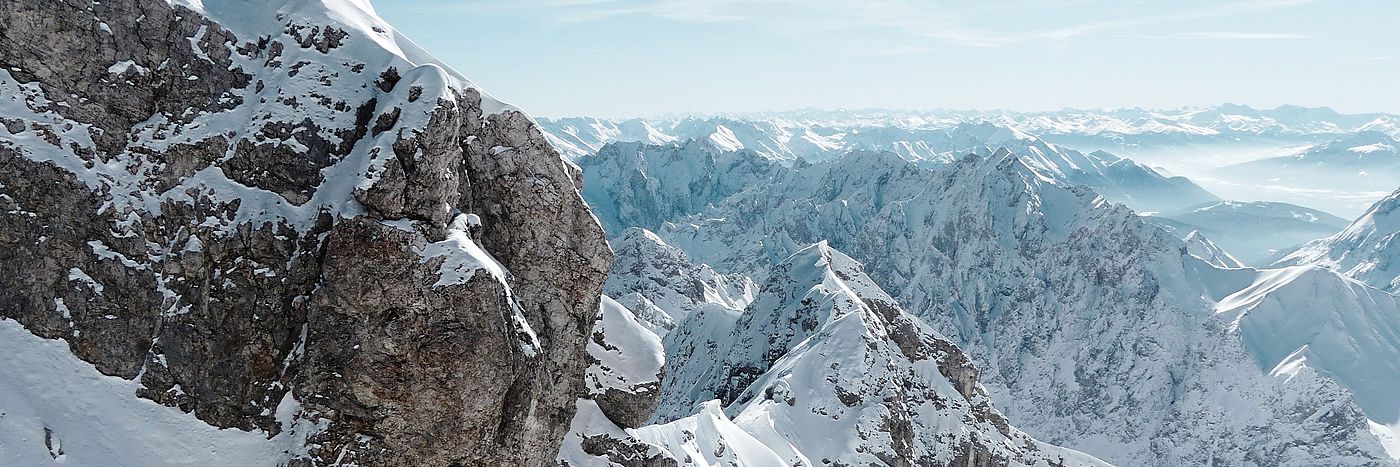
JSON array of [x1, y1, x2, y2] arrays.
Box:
[[0, 319, 318, 467]]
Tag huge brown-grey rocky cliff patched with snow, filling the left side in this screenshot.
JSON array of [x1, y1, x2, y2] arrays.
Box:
[[0, 0, 612, 466]]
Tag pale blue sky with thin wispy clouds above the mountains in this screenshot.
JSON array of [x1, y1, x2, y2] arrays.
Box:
[[372, 0, 1400, 117]]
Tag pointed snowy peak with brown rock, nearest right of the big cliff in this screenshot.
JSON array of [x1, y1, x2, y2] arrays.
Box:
[[561, 243, 1103, 466]]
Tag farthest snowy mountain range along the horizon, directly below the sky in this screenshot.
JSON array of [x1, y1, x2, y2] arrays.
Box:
[[540, 103, 1400, 159]]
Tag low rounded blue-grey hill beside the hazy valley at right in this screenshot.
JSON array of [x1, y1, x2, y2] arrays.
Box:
[[1144, 201, 1348, 266]]
